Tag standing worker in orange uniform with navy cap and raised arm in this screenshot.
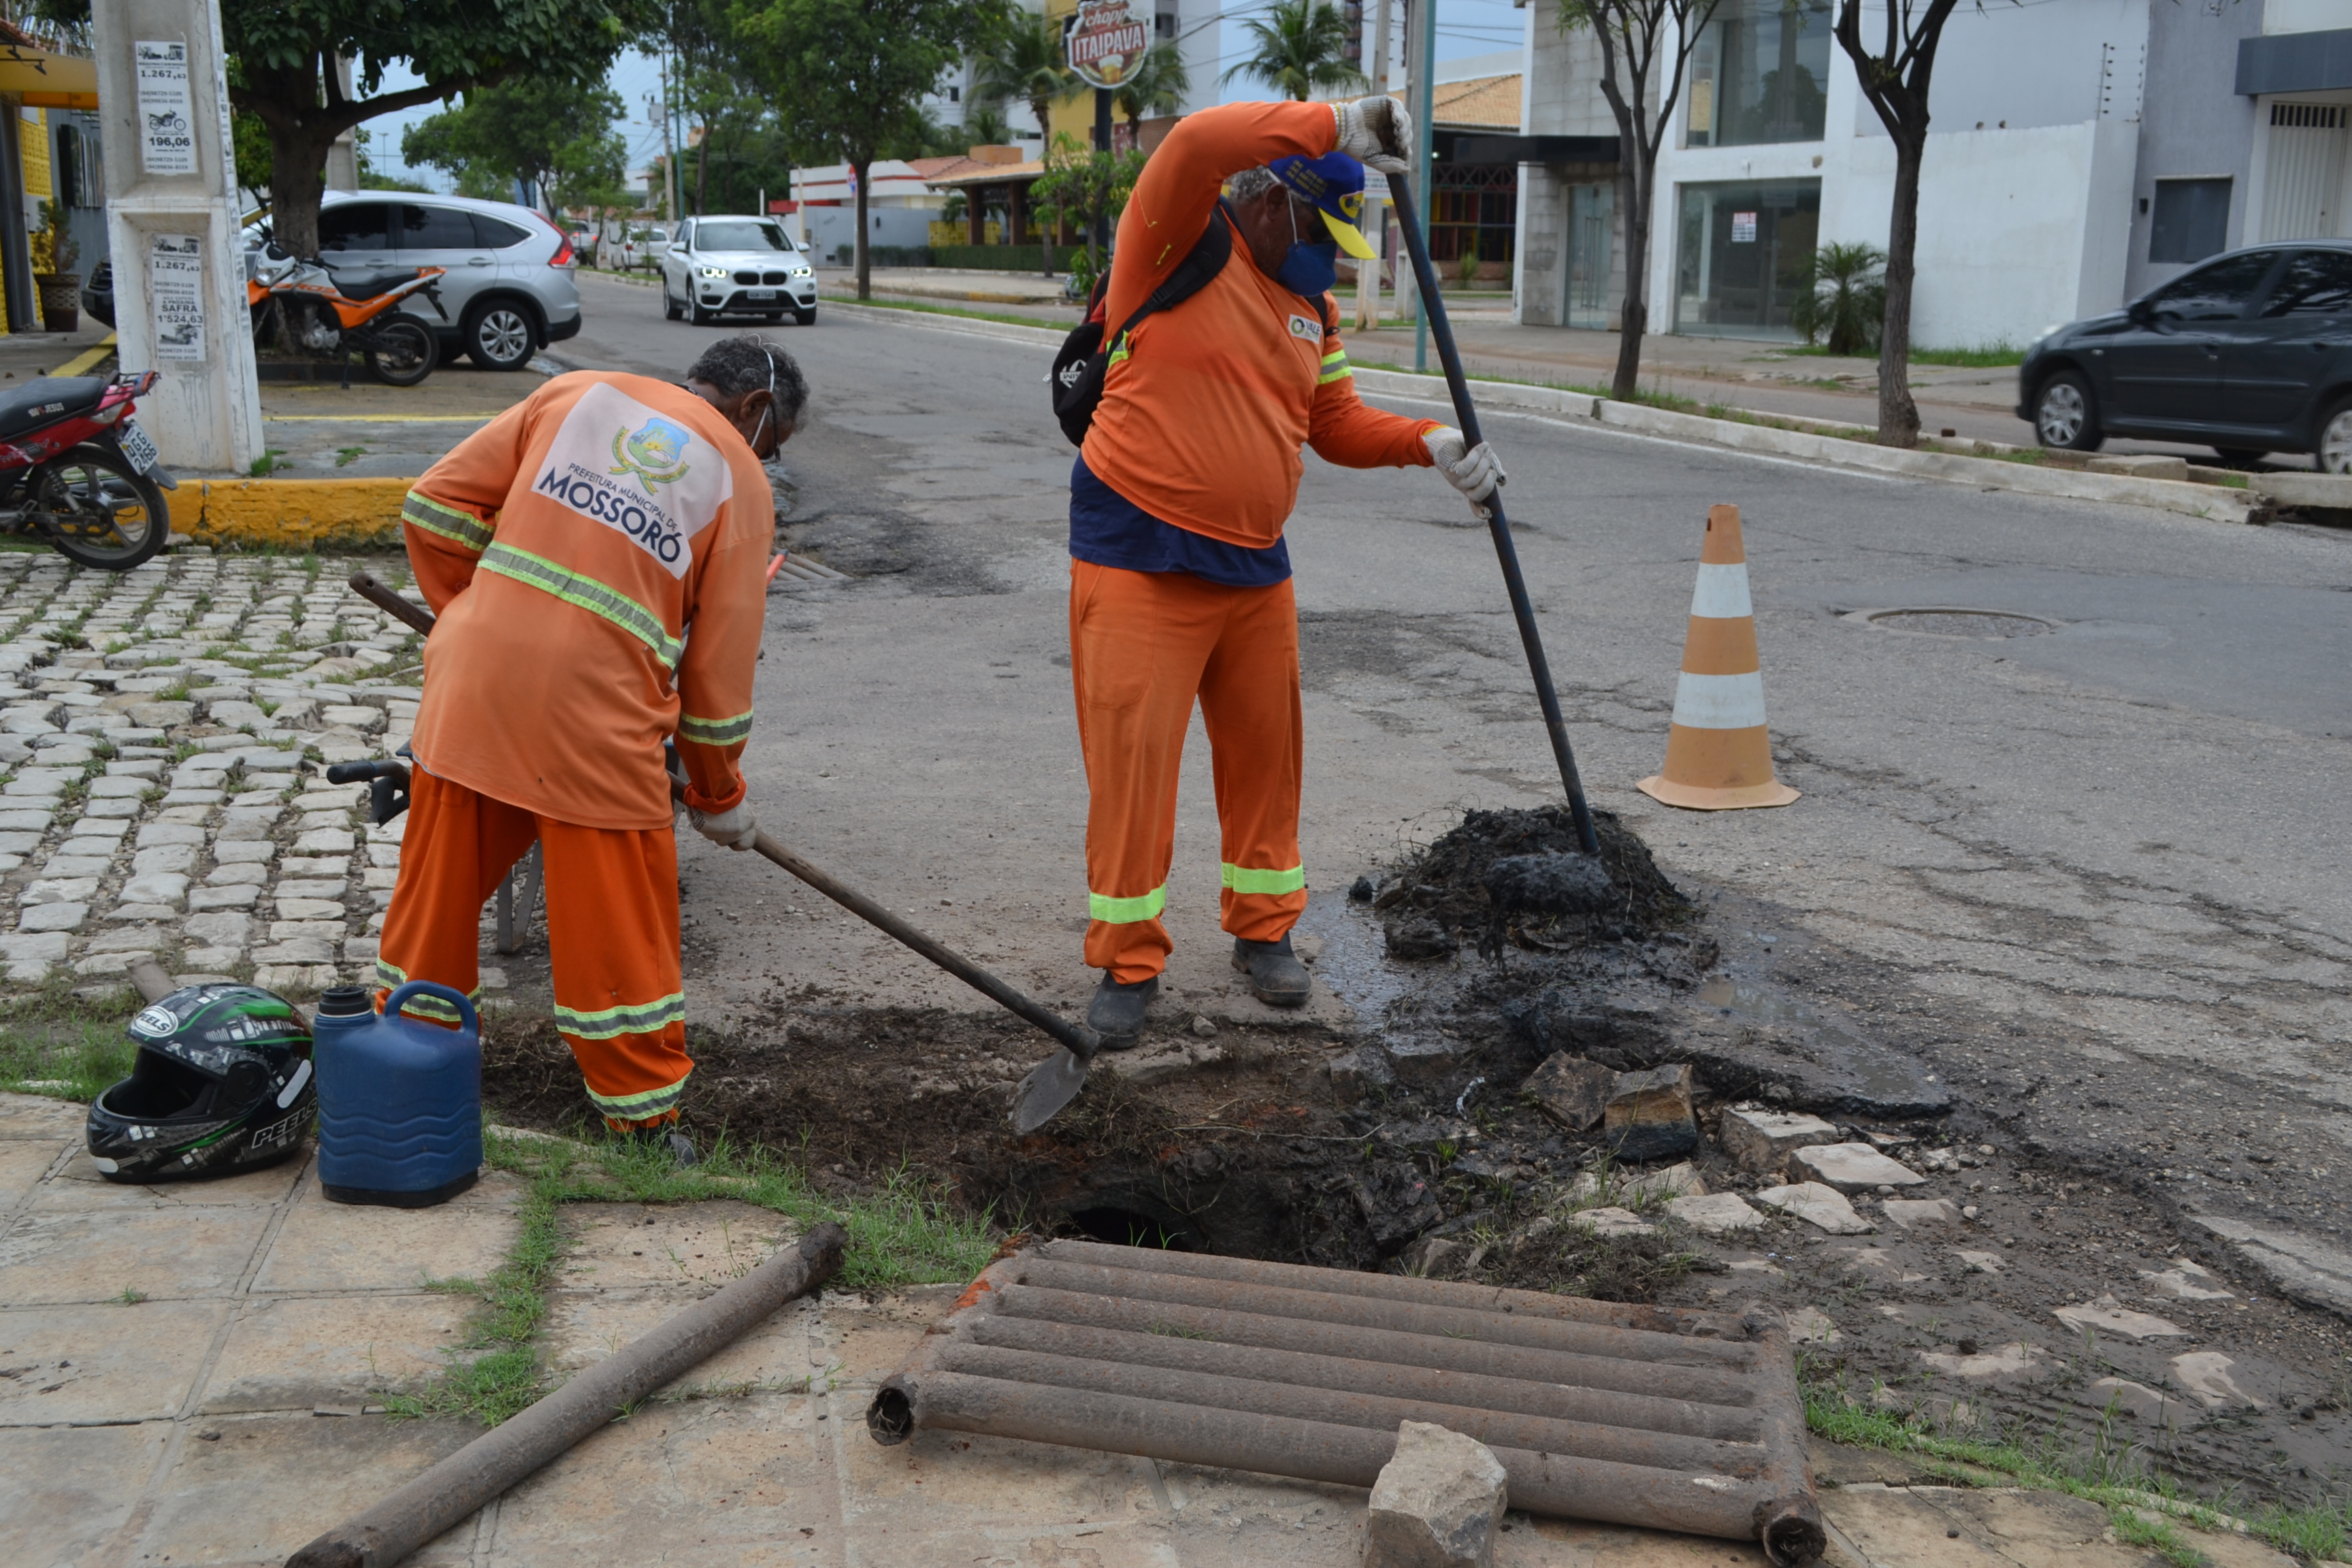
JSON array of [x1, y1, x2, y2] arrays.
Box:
[[1070, 97, 1503, 1049]]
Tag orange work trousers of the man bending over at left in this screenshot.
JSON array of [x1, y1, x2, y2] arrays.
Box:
[[376, 769, 694, 1131]]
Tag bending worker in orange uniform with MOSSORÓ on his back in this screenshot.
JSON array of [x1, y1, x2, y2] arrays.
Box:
[[376, 336, 809, 1164]]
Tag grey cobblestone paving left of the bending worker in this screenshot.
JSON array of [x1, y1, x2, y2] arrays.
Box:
[[0, 553, 421, 992]]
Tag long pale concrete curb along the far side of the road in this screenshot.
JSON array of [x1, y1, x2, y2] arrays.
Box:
[[840, 301, 2258, 522]]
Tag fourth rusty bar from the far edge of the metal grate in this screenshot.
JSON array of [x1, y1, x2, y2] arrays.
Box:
[[969, 1309, 1764, 1443]]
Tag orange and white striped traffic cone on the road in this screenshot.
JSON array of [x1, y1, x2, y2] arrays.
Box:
[[1637, 506, 1797, 811]]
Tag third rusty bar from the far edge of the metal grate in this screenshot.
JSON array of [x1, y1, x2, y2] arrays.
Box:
[[995, 1284, 1750, 1408]]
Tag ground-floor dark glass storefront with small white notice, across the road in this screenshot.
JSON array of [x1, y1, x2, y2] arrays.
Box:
[[1675, 179, 1820, 338]]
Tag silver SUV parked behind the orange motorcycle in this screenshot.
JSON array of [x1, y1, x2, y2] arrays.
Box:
[[318, 191, 581, 369]]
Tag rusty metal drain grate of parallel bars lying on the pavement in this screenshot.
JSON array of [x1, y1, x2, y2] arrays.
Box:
[[866, 1241, 1823, 1563]]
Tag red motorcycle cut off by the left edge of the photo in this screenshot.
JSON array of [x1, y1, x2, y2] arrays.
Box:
[[0, 372, 179, 571]]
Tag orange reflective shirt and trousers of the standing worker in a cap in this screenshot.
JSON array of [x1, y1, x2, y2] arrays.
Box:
[[1070, 103, 1437, 983]]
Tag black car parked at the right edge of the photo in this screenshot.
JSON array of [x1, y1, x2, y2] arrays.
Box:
[[2018, 240, 2352, 472]]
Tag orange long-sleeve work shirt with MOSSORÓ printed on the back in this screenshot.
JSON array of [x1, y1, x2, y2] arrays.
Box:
[[402, 372, 776, 828]]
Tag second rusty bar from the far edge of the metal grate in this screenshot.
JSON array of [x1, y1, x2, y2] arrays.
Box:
[[1018, 1258, 1754, 1371]]
